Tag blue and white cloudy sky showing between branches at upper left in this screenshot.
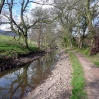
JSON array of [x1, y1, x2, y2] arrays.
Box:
[[0, 0, 52, 31]]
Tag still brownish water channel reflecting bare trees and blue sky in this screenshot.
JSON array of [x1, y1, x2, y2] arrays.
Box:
[[0, 52, 59, 99]]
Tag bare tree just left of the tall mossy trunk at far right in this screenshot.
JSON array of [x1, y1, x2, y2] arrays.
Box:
[[73, 1, 87, 49]]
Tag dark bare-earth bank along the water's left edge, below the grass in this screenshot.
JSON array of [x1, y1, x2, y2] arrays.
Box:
[[0, 49, 55, 72]]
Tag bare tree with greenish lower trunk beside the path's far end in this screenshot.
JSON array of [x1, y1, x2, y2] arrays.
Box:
[[54, 0, 76, 47]]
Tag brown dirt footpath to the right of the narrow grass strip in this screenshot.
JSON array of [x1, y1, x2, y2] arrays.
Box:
[[75, 53, 99, 99]]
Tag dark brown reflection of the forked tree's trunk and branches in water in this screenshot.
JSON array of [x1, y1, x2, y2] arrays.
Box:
[[10, 67, 33, 99]]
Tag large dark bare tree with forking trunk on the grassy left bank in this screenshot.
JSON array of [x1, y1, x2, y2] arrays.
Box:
[[5, 0, 39, 48]]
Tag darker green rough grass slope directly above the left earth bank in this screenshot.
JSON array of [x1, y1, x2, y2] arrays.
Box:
[[0, 43, 39, 59]]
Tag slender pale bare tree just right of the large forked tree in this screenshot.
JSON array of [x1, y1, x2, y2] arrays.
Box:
[[32, 7, 49, 48]]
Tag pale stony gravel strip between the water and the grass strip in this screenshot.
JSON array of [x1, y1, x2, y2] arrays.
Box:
[[23, 51, 72, 99]]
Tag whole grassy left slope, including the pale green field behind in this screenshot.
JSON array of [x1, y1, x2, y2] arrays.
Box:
[[0, 35, 38, 58]]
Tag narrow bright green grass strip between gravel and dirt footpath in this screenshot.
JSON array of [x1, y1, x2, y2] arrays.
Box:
[[69, 52, 86, 99]]
